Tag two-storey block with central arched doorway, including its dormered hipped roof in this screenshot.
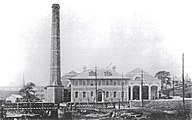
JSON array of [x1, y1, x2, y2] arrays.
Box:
[[70, 69, 129, 102]]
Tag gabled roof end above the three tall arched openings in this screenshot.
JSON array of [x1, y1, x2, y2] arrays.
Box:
[[125, 68, 159, 81]]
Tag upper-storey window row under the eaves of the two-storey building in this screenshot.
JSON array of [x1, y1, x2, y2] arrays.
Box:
[[71, 80, 128, 86]]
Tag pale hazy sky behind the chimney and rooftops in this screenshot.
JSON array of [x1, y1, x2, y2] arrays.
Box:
[[0, 0, 192, 86]]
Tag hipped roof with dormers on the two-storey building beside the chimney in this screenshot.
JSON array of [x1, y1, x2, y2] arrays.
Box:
[[71, 68, 128, 79]]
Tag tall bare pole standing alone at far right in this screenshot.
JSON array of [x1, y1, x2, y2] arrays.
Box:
[[182, 53, 185, 115]]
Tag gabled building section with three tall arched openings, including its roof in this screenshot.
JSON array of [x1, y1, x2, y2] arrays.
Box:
[[125, 68, 161, 100]]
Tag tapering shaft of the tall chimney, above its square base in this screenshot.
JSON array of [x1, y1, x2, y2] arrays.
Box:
[[50, 4, 62, 85]]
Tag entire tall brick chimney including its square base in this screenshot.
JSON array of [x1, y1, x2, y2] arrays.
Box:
[[45, 4, 64, 103]]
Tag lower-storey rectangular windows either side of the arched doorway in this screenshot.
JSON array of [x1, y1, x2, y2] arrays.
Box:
[[75, 91, 124, 98]]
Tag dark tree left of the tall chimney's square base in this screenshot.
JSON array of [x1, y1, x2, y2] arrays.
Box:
[[19, 82, 36, 102]]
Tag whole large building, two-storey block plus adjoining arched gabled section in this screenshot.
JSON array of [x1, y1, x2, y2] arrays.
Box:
[[70, 68, 161, 102]]
